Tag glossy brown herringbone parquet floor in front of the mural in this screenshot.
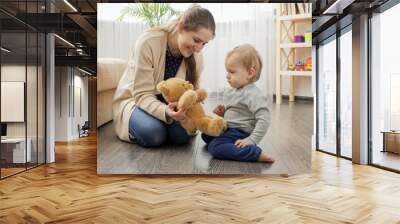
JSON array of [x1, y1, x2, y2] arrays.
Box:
[[0, 136, 400, 224]]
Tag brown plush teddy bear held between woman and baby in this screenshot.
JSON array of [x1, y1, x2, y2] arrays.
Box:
[[157, 78, 227, 136]]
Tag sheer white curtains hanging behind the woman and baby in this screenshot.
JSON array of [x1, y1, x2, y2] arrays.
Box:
[[97, 3, 276, 97]]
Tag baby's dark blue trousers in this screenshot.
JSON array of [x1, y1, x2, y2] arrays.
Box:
[[201, 128, 261, 162]]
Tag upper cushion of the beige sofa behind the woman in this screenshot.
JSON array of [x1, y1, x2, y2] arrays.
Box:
[[97, 58, 126, 92]]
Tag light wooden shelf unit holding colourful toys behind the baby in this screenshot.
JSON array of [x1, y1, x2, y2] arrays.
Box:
[[275, 3, 312, 104]]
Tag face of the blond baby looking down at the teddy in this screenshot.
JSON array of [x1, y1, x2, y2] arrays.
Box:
[[226, 56, 252, 89]]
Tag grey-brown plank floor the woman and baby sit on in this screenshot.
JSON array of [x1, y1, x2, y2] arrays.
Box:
[[97, 99, 313, 174]]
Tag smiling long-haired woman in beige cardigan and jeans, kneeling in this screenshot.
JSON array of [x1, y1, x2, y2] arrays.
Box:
[[113, 6, 215, 147]]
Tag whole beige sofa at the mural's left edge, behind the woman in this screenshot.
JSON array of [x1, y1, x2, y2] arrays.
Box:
[[97, 58, 127, 127]]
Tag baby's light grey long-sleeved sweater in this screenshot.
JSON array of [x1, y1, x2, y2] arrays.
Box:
[[223, 83, 271, 144]]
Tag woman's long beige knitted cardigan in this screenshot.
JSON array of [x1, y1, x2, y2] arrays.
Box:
[[112, 30, 203, 141]]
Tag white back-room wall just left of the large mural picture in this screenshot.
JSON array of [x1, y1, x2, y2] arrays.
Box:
[[55, 67, 88, 141]]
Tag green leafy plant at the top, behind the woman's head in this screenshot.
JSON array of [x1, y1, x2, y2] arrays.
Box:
[[117, 3, 181, 27]]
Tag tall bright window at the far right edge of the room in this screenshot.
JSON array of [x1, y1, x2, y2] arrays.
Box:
[[370, 4, 400, 171]]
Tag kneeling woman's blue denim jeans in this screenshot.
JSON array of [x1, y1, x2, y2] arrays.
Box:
[[129, 107, 192, 147]]
